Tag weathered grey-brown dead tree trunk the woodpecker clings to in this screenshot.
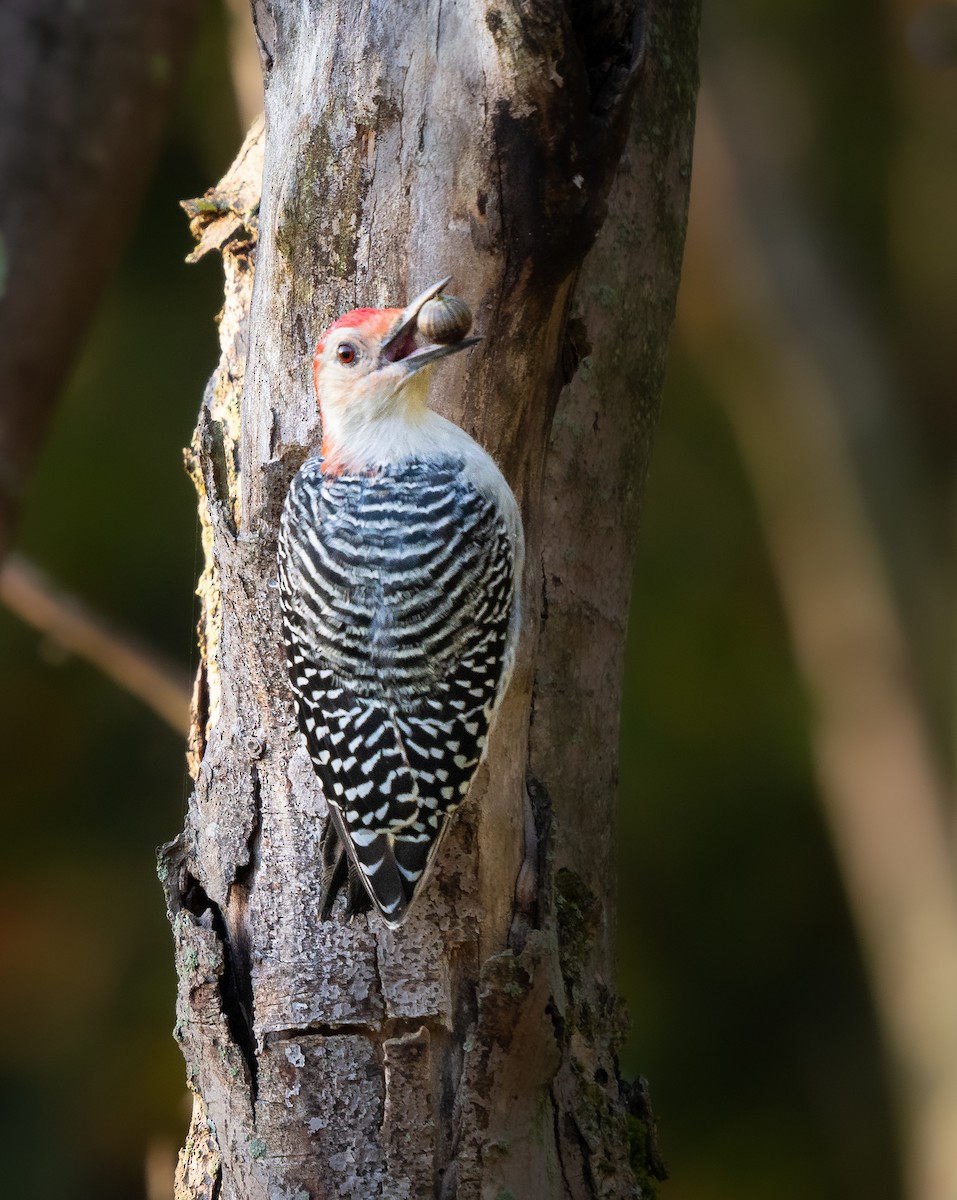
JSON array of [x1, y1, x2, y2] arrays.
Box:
[[161, 0, 697, 1200]]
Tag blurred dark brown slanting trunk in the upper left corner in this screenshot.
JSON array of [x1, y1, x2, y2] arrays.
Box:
[[0, 0, 197, 558]]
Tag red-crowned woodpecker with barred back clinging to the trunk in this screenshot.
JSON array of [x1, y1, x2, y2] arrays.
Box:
[[278, 280, 524, 926]]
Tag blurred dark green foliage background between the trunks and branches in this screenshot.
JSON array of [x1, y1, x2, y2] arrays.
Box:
[[0, 0, 957, 1200]]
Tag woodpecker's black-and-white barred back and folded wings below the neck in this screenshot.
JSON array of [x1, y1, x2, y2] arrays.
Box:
[[279, 458, 516, 924]]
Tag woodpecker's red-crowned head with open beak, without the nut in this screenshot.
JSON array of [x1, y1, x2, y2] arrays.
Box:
[[313, 278, 480, 473]]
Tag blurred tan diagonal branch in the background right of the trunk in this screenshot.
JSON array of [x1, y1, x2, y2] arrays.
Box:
[[679, 90, 957, 1200]]
